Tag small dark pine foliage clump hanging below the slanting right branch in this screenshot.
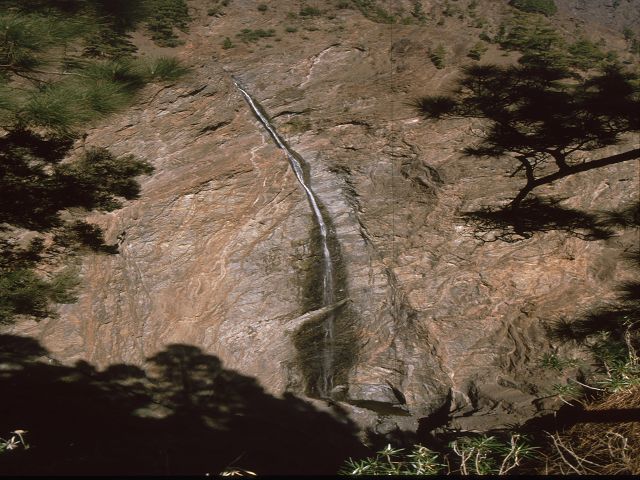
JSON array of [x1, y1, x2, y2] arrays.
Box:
[[462, 197, 628, 242]]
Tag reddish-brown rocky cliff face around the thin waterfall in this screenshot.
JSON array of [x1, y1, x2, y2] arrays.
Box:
[[6, 0, 638, 433]]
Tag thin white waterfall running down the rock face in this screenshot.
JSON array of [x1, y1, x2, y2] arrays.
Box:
[[232, 77, 335, 397]]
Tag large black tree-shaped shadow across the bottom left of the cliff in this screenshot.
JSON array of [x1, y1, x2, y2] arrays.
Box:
[[0, 335, 364, 475]]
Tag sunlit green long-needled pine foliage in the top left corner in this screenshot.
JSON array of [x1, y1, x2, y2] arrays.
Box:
[[0, 6, 185, 135]]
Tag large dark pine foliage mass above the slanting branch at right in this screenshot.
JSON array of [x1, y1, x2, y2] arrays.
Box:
[[415, 63, 640, 209]]
